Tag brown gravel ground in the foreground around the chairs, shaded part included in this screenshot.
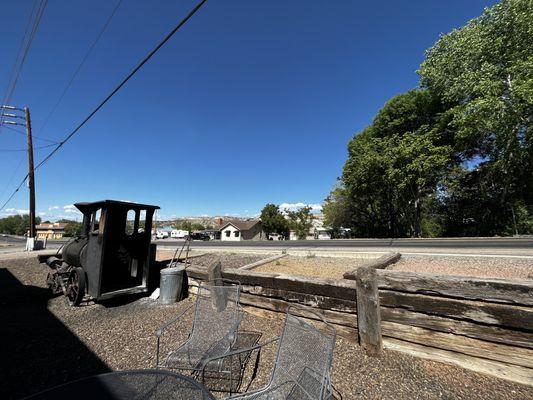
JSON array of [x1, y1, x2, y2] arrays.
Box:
[[0, 259, 533, 400]]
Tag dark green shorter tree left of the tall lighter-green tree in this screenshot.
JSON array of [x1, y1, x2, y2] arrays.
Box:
[[332, 90, 455, 237]]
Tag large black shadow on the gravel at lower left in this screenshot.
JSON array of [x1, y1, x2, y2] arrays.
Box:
[[0, 268, 110, 399]]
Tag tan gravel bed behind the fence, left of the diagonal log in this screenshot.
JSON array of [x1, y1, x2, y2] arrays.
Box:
[[254, 256, 365, 279]]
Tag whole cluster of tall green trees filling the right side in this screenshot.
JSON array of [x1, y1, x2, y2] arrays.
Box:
[[323, 0, 533, 237]]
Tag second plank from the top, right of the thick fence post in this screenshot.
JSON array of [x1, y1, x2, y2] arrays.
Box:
[[379, 290, 533, 331]]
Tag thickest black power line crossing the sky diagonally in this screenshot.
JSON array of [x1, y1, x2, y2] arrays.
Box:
[[0, 0, 207, 210]]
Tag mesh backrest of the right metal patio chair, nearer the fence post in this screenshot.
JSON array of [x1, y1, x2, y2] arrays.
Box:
[[269, 308, 335, 400]]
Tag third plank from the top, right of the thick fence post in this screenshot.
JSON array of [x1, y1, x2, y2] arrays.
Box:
[[381, 307, 533, 349]]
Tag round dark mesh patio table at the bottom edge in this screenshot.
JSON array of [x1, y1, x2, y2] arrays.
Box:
[[22, 370, 214, 400]]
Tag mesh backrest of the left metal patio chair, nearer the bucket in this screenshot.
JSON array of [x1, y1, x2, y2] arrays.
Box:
[[191, 283, 241, 352]]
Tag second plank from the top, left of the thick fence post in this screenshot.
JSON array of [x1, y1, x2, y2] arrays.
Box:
[[242, 285, 357, 314]]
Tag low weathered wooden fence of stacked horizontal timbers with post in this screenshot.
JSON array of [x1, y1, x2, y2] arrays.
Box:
[[187, 267, 533, 385]]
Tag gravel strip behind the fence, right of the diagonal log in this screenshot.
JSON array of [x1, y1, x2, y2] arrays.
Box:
[[387, 256, 533, 279]]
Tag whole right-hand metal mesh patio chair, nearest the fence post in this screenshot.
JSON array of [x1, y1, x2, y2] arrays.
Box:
[[202, 306, 336, 400]]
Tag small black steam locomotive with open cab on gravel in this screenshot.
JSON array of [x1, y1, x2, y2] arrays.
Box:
[[41, 200, 159, 305]]
